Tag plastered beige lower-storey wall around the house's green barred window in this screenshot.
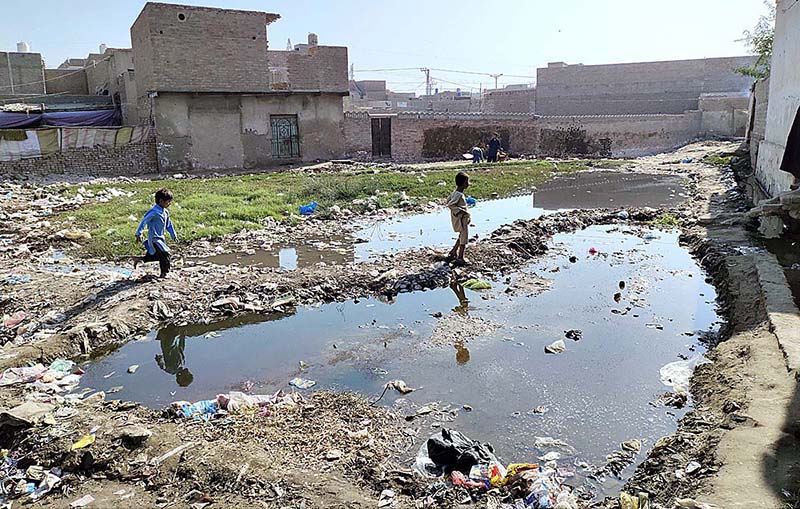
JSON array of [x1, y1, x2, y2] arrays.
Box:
[[155, 93, 344, 171]]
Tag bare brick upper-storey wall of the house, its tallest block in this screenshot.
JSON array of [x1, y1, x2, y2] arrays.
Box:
[[131, 3, 276, 94]]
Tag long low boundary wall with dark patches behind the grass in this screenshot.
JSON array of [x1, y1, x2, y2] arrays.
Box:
[[344, 111, 702, 161]]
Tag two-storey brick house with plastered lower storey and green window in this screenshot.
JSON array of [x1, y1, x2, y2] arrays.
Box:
[[131, 3, 349, 171]]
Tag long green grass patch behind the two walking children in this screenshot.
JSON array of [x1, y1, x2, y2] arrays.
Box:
[[62, 161, 617, 257]]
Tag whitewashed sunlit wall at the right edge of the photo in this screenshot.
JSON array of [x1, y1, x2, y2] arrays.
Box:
[[756, 0, 800, 196]]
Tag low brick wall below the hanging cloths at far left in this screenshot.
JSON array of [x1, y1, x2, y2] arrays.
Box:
[[0, 141, 158, 180]]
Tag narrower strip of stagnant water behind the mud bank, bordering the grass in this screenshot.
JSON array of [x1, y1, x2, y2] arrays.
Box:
[[198, 171, 684, 270]]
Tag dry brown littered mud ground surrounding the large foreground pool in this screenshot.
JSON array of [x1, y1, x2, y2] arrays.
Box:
[[0, 143, 800, 508]]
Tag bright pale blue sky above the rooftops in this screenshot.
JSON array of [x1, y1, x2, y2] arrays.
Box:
[[0, 0, 766, 92]]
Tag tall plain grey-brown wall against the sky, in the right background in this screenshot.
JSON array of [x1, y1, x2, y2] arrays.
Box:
[[536, 56, 755, 115]]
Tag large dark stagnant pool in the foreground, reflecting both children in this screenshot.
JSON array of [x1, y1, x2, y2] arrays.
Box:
[[82, 223, 718, 493]]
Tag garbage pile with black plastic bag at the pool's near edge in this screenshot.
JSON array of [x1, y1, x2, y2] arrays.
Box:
[[416, 428, 579, 509]]
